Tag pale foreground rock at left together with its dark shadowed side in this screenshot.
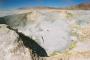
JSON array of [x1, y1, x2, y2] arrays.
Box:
[[0, 24, 47, 60]]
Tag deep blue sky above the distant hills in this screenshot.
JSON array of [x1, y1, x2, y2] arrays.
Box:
[[0, 0, 90, 9]]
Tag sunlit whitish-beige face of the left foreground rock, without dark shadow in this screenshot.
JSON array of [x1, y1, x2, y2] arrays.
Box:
[[0, 24, 32, 60]]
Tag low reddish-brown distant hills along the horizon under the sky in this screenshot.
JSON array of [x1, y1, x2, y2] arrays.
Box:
[[18, 3, 90, 10]]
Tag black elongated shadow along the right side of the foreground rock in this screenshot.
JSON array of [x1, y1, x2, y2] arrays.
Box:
[[18, 33, 47, 57]]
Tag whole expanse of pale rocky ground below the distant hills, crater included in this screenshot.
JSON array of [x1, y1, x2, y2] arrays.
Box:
[[0, 8, 90, 60]]
